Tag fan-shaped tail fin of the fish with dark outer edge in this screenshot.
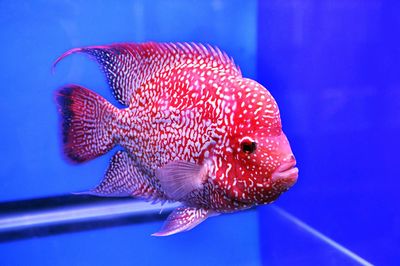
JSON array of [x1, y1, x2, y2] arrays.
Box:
[[56, 85, 118, 162]]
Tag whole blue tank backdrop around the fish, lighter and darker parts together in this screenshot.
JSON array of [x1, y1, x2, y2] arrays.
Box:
[[0, 0, 400, 265]]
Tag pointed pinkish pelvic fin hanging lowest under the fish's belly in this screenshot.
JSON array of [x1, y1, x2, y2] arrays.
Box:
[[152, 207, 216, 236]]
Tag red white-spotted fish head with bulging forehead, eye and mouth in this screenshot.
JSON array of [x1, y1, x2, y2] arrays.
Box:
[[216, 79, 298, 205]]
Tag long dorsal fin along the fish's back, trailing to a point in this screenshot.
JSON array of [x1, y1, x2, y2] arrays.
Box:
[[53, 42, 241, 106]]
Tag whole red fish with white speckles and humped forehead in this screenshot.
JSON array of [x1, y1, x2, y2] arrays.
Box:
[[53, 42, 298, 236]]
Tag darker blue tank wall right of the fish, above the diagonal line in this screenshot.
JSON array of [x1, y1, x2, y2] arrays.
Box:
[[257, 0, 400, 265]]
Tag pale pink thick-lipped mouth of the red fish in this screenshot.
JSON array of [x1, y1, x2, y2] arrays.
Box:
[[271, 161, 299, 190]]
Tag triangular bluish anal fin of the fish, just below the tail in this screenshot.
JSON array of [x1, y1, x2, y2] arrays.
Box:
[[80, 151, 162, 200]]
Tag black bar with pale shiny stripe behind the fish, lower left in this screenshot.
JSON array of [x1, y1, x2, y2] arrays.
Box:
[[0, 195, 179, 242]]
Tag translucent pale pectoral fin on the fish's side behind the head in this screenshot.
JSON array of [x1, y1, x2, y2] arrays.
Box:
[[156, 161, 207, 200]]
